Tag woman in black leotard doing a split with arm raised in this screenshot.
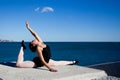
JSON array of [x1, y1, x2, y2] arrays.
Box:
[[16, 22, 78, 72]]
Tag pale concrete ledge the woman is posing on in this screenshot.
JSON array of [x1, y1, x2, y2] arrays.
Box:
[[0, 65, 107, 80]]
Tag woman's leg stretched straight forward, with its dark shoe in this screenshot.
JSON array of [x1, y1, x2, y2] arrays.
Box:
[[48, 59, 76, 66]]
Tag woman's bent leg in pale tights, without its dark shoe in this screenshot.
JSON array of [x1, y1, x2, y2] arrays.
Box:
[[16, 46, 35, 68]]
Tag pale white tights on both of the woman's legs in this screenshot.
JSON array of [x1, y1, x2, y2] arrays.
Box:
[[16, 47, 73, 68]]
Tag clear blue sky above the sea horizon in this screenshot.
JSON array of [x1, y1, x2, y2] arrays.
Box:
[[0, 0, 120, 42]]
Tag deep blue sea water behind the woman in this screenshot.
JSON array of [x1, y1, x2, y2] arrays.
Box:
[[0, 42, 120, 66]]
